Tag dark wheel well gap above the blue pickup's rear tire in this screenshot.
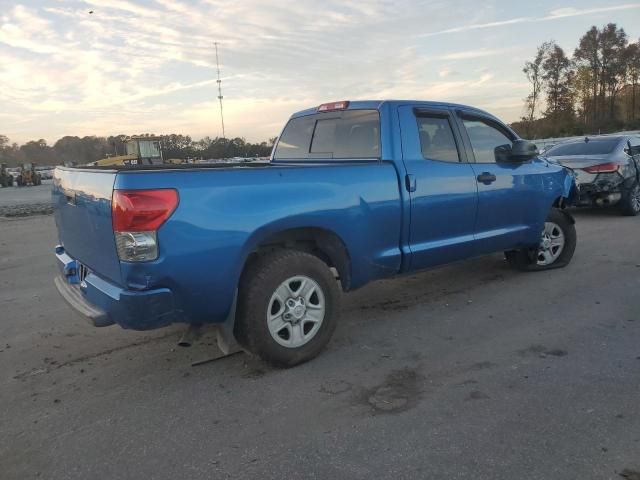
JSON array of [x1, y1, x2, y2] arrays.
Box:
[[242, 228, 351, 291]]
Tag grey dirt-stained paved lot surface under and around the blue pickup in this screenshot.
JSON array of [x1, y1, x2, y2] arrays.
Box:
[[0, 212, 640, 480]]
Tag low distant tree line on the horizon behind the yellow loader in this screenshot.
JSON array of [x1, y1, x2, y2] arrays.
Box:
[[0, 134, 275, 166]]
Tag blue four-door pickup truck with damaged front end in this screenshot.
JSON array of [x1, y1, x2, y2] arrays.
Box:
[[53, 101, 576, 367]]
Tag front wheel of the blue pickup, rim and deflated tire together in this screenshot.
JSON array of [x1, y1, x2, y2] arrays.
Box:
[[505, 208, 577, 271]]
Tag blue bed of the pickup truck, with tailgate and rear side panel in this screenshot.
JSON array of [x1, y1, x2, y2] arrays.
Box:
[[53, 160, 402, 329]]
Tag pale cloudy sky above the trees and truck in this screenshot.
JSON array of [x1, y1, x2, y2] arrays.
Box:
[[0, 0, 640, 142]]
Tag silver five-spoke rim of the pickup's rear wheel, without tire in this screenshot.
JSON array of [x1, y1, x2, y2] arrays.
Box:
[[267, 275, 326, 348]]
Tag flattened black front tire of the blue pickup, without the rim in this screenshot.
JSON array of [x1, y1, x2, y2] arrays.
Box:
[[504, 208, 577, 272]]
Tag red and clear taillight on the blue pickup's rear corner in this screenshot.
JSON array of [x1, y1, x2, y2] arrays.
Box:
[[111, 189, 178, 262]]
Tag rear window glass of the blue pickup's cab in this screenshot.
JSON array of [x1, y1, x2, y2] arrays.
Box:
[[273, 110, 380, 160]]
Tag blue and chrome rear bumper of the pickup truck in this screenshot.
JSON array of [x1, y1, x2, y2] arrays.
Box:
[[54, 247, 179, 330]]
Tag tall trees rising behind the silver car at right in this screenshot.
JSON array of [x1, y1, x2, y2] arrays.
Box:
[[512, 23, 640, 138]]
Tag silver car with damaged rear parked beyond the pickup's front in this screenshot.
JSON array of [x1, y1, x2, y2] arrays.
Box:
[[544, 135, 640, 215]]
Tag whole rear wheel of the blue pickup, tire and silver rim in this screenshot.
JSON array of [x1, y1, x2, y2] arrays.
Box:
[[235, 250, 340, 367]]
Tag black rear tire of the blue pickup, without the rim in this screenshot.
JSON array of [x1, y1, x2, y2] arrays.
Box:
[[234, 250, 340, 368]]
